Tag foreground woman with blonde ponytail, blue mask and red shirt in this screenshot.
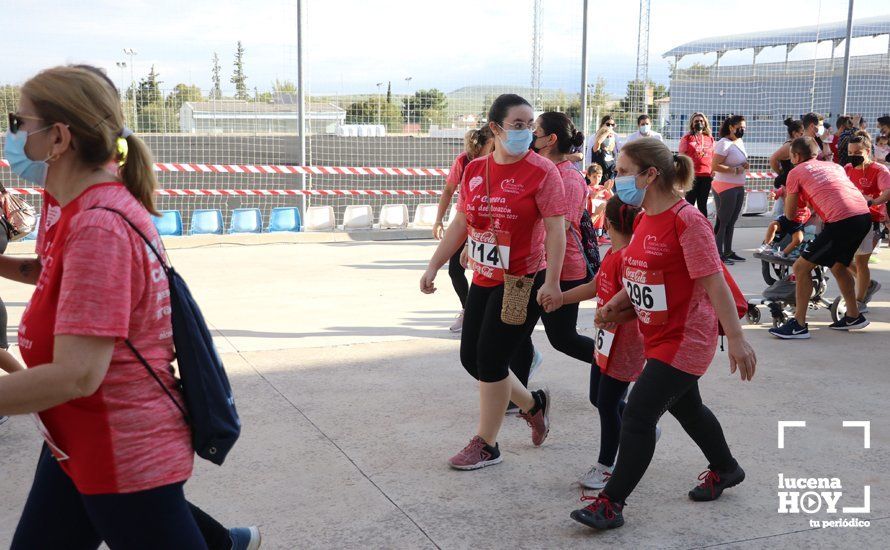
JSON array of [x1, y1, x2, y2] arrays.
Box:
[[0, 67, 206, 548]]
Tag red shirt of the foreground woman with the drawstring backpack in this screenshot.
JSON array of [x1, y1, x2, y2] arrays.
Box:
[[19, 183, 194, 494]]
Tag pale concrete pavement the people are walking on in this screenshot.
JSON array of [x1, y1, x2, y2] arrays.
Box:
[[0, 228, 890, 549]]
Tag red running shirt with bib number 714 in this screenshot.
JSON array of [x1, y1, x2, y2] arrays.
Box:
[[457, 151, 566, 287]]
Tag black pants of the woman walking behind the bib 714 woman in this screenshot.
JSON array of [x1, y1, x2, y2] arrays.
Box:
[[510, 279, 596, 380]]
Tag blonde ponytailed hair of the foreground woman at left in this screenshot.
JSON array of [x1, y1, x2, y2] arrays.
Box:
[[22, 67, 158, 215]]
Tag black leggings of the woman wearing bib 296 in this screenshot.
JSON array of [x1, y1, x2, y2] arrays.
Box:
[[603, 359, 738, 503]]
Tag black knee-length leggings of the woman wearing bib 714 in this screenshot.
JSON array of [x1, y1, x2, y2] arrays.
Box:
[[460, 271, 545, 382]]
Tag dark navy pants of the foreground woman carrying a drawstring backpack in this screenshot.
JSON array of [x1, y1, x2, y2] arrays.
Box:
[[11, 446, 207, 550]]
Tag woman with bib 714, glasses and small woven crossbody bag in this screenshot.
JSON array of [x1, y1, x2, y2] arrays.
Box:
[[420, 94, 566, 470]]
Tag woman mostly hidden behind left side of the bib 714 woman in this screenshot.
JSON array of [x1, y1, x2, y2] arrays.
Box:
[[433, 126, 494, 332]]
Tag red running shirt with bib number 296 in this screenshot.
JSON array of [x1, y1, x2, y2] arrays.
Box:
[[621, 200, 723, 376]]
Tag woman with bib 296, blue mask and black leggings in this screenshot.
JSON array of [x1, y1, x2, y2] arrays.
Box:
[[572, 139, 756, 529]]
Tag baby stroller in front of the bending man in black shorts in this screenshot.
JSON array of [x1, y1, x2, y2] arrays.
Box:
[[748, 225, 834, 327]]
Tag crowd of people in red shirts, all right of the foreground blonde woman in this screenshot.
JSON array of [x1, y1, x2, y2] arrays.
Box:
[[420, 94, 890, 529]]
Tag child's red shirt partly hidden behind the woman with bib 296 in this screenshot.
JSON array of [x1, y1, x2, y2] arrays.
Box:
[[594, 248, 645, 382]]
